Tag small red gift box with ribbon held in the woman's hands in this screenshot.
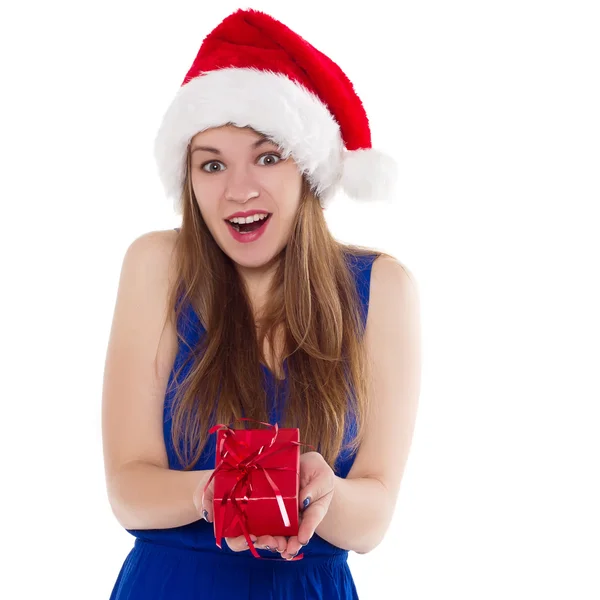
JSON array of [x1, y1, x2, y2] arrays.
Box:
[[207, 419, 301, 557]]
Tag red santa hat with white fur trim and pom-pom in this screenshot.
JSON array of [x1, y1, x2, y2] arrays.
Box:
[[154, 9, 396, 214]]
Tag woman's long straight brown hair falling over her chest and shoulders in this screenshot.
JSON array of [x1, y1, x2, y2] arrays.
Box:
[[162, 138, 392, 470]]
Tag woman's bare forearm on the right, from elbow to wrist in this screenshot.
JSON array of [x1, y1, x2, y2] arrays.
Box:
[[315, 476, 394, 554]]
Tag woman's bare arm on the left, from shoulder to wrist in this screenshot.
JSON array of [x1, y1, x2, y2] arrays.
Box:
[[102, 231, 206, 529]]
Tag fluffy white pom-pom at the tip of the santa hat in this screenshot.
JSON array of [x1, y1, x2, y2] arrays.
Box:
[[340, 148, 398, 202]]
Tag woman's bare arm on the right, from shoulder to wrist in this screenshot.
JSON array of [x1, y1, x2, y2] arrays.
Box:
[[314, 257, 421, 554]]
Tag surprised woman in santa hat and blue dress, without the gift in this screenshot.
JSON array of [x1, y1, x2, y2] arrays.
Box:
[[103, 10, 420, 600]]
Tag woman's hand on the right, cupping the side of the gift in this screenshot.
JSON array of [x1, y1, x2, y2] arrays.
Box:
[[281, 452, 335, 560]]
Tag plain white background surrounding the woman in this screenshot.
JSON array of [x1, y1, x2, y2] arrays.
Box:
[[0, 0, 600, 600]]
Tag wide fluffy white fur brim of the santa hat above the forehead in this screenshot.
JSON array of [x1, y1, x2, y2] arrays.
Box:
[[154, 68, 344, 214]]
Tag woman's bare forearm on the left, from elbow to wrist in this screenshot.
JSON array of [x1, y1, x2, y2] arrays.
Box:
[[107, 462, 212, 529]]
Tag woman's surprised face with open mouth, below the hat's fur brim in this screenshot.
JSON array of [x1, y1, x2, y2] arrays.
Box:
[[190, 125, 302, 274]]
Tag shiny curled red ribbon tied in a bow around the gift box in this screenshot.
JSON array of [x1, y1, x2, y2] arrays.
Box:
[[202, 417, 312, 560]]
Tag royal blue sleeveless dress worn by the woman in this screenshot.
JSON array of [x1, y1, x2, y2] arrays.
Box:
[[110, 231, 377, 600]]
